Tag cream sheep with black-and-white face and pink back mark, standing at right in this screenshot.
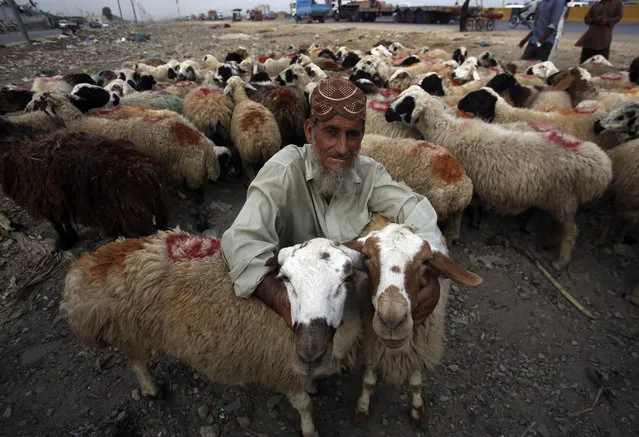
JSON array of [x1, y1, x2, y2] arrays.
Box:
[[386, 86, 612, 269]]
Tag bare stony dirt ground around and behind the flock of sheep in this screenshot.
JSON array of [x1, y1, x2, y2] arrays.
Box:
[[0, 23, 639, 437]]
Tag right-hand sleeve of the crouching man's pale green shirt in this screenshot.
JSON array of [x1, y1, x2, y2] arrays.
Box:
[[368, 164, 448, 254]]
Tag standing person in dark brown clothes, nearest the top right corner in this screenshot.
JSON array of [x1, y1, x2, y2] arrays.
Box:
[[575, 0, 623, 64]]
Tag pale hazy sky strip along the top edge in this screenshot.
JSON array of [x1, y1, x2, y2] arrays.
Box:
[[30, 0, 513, 19]]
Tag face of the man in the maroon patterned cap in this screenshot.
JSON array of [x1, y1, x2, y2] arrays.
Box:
[[304, 115, 364, 172]]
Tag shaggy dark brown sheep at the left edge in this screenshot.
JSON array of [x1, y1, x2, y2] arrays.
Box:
[[0, 131, 169, 250]]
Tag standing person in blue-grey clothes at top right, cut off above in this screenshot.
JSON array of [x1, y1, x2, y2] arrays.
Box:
[[519, 0, 567, 61]]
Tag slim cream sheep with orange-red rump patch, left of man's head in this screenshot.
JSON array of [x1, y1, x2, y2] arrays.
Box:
[[224, 76, 282, 181]]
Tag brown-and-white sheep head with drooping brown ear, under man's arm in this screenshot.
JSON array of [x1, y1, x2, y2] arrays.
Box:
[[346, 223, 483, 349]]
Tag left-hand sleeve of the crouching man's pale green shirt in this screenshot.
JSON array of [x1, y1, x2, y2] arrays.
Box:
[[221, 163, 288, 297]]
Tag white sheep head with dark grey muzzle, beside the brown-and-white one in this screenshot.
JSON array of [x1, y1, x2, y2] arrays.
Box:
[[277, 238, 363, 374]]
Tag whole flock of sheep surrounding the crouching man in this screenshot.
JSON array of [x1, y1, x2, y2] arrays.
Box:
[[0, 38, 639, 437]]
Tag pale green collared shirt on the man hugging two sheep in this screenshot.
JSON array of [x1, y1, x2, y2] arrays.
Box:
[[222, 144, 446, 297]]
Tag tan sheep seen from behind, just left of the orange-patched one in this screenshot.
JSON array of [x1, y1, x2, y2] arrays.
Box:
[[183, 86, 233, 146]]
